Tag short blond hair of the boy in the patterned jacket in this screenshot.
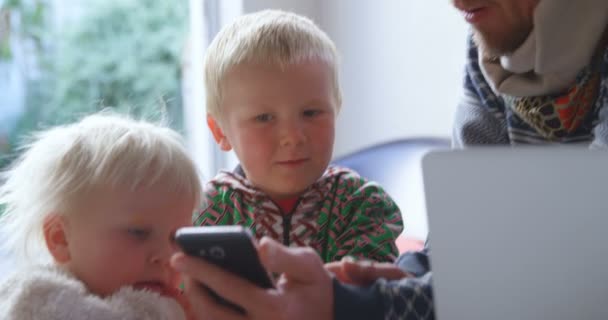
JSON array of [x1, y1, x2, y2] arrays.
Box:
[[204, 10, 342, 118]]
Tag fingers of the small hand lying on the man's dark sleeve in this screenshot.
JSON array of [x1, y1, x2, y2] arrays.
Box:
[[342, 261, 410, 285]]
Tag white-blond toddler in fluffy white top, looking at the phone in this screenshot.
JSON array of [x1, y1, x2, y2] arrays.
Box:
[[0, 114, 201, 320]]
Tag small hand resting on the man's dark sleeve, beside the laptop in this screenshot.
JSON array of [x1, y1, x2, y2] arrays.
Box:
[[325, 257, 412, 286]]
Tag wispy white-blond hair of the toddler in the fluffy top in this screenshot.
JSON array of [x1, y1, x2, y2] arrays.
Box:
[[0, 112, 201, 264]]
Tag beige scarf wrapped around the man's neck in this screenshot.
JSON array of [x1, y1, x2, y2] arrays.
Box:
[[479, 0, 608, 97]]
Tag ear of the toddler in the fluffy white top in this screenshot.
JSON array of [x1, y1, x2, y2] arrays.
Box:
[[43, 214, 70, 264]]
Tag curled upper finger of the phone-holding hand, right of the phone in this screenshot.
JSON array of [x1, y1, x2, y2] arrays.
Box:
[[258, 237, 330, 283]]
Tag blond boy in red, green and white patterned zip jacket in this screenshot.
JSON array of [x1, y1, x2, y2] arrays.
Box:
[[194, 10, 403, 262]]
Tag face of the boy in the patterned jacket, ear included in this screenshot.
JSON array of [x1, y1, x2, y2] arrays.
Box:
[[213, 61, 338, 200]]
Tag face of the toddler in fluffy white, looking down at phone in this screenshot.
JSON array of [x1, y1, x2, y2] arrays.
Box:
[[53, 184, 194, 296]]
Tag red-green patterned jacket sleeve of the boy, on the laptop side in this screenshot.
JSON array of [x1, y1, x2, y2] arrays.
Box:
[[324, 175, 403, 262]]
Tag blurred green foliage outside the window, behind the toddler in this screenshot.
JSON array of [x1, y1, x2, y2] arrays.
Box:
[[0, 0, 188, 168]]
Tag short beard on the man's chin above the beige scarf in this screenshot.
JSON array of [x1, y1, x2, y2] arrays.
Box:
[[473, 25, 532, 59]]
